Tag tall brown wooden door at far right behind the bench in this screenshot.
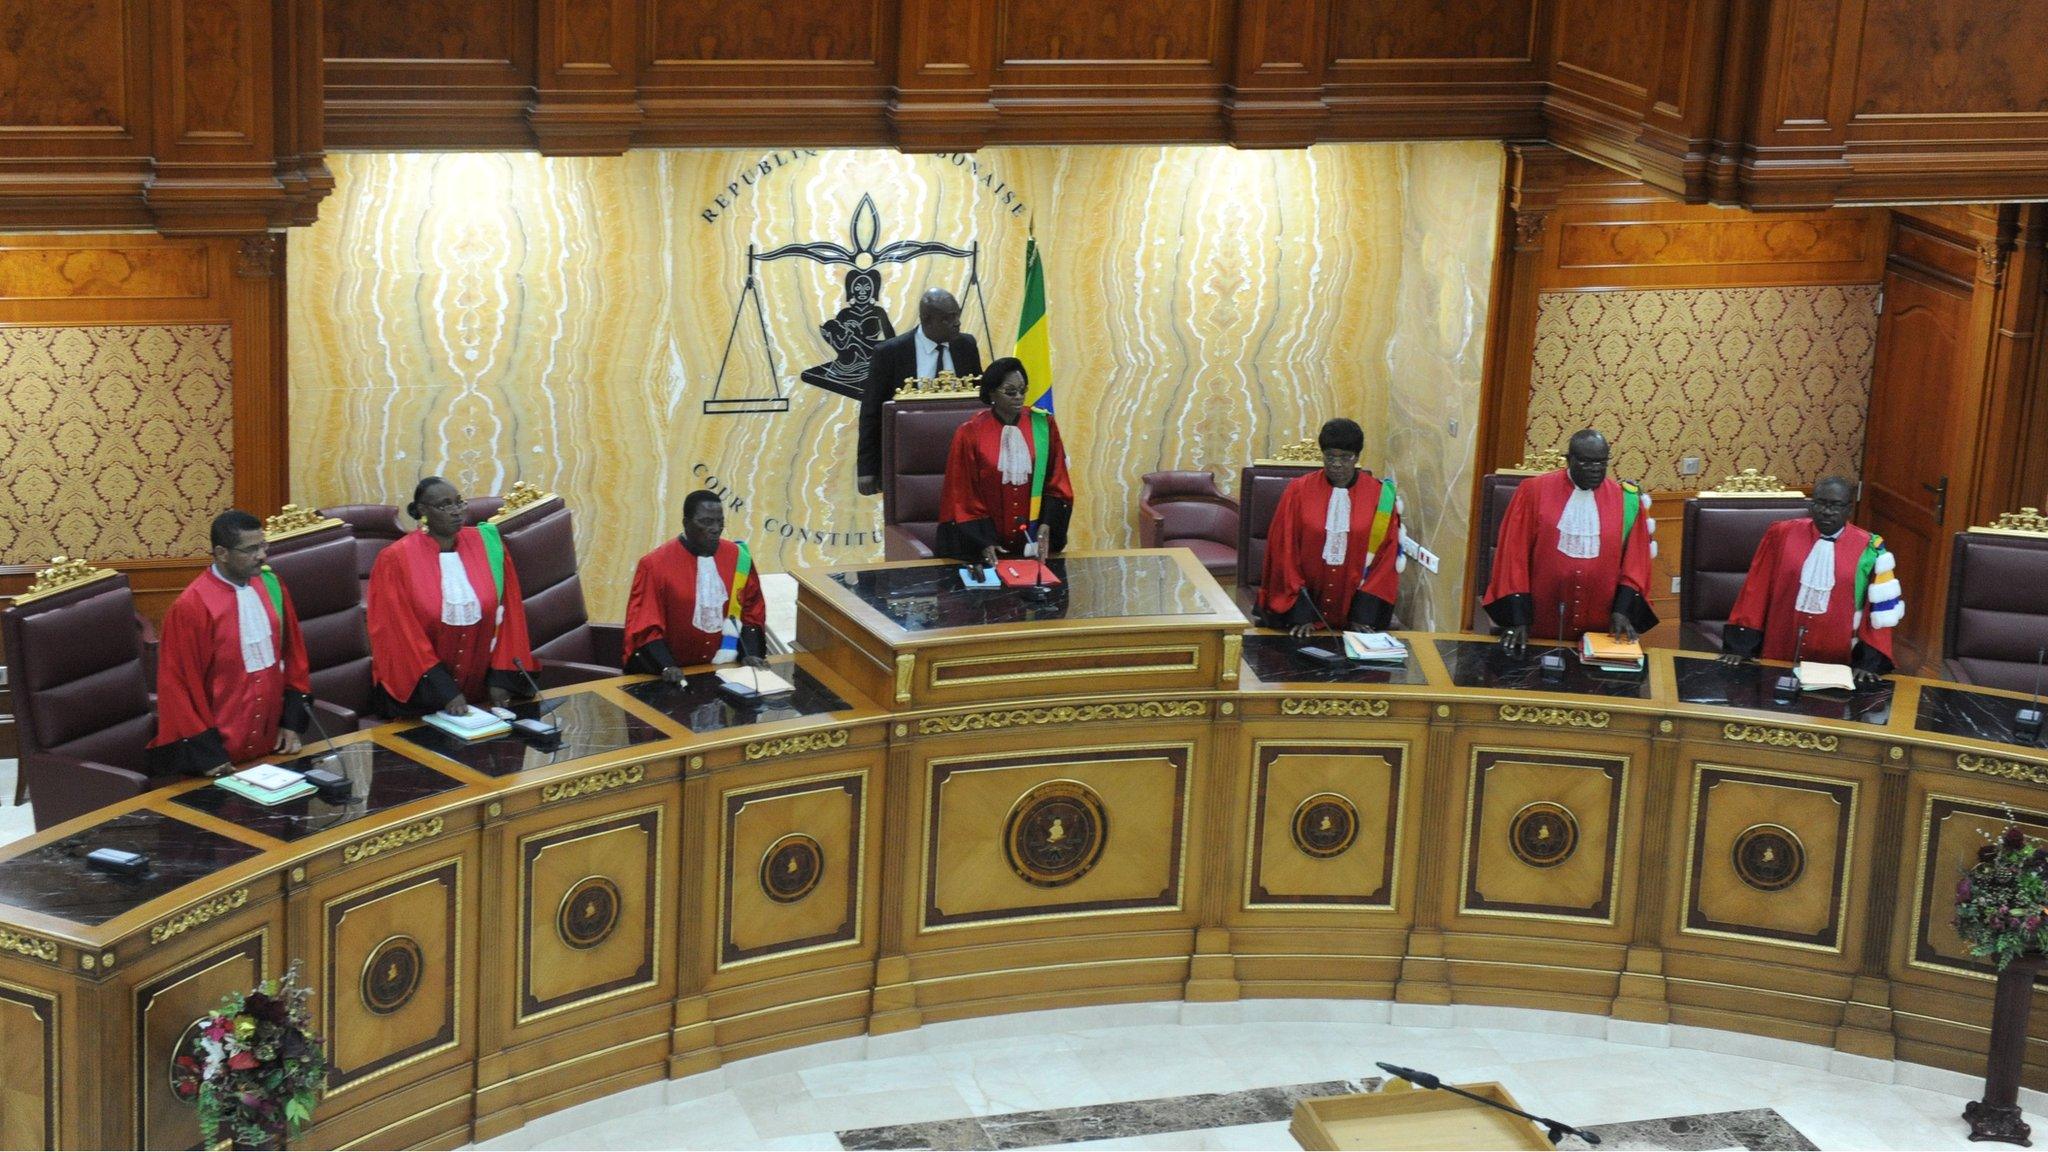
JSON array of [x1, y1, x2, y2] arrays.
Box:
[[1860, 258, 1976, 654]]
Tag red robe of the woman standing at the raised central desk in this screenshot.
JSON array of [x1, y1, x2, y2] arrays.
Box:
[[938, 408, 1073, 564]]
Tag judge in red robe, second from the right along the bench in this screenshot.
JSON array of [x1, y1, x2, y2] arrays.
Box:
[[1485, 428, 1657, 656]]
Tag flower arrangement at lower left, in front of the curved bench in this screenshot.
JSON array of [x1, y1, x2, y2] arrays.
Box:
[[172, 961, 328, 1148]]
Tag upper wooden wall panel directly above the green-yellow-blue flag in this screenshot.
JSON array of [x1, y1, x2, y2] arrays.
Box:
[[993, 0, 1235, 141]]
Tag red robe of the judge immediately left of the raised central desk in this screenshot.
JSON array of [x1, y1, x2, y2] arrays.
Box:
[[625, 539, 768, 674]]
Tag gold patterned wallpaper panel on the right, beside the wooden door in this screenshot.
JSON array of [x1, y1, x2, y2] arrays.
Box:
[[1528, 285, 1878, 490]]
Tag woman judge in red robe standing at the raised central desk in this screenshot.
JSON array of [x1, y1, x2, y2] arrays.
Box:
[[938, 357, 1073, 566]]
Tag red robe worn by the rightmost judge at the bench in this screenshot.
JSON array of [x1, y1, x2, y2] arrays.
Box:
[[1720, 519, 1905, 672]]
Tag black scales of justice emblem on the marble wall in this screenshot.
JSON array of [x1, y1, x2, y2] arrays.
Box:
[[705, 193, 989, 416]]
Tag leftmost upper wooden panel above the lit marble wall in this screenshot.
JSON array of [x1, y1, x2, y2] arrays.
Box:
[[322, 0, 537, 150]]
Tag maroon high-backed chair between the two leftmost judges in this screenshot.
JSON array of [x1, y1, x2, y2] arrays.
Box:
[[264, 504, 377, 725]]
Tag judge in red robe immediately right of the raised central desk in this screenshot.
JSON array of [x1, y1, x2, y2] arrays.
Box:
[[1257, 418, 1407, 635]]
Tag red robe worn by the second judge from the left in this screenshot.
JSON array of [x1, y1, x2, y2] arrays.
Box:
[[369, 527, 539, 711]]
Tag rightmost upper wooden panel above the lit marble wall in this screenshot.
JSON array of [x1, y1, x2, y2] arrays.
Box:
[[1323, 0, 1554, 139]]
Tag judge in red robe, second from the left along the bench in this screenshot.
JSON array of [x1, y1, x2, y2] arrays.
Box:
[[369, 476, 539, 715]]
